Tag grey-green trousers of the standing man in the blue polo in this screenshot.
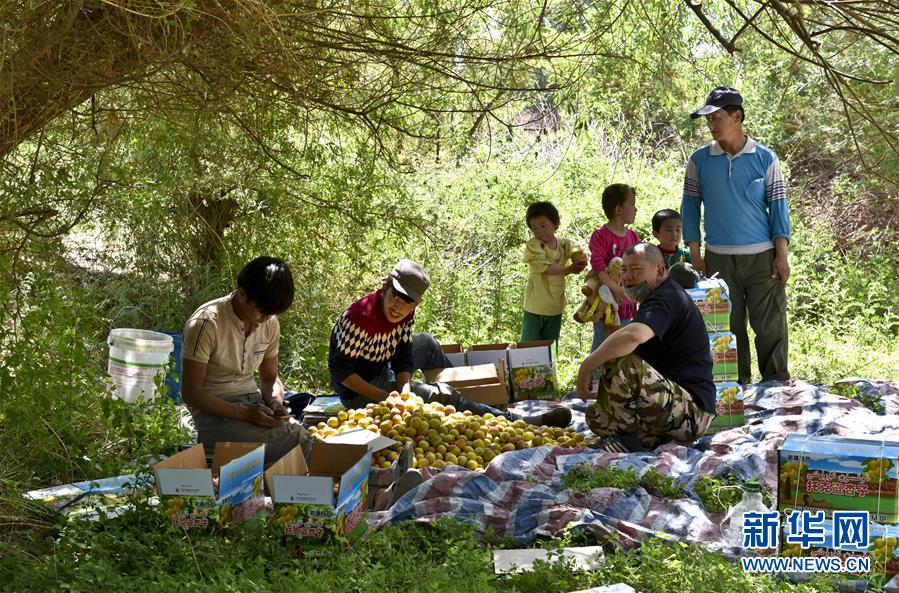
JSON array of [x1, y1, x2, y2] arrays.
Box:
[[705, 249, 790, 385]]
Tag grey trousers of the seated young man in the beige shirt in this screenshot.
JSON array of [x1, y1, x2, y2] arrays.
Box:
[[190, 391, 312, 465]]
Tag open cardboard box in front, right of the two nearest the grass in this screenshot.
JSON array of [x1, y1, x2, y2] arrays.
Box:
[[265, 430, 394, 557]]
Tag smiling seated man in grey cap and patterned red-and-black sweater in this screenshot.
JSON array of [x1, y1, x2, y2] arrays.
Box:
[[328, 259, 571, 426]]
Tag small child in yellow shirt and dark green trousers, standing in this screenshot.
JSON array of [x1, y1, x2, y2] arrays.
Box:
[[521, 202, 587, 342]]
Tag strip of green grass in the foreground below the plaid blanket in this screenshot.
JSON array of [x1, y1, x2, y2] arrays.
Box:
[[0, 507, 835, 593]]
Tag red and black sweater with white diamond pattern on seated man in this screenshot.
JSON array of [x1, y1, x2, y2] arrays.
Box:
[[328, 292, 415, 397]]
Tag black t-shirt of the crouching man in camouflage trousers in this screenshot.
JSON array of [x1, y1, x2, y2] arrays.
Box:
[[634, 278, 715, 414]]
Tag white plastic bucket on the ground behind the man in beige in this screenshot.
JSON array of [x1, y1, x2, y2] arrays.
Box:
[[106, 328, 174, 402]]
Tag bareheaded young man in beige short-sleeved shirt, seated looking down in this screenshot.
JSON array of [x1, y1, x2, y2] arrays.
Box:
[[181, 257, 309, 464]]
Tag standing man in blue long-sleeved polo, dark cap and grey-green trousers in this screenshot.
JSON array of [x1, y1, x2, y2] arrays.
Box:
[[681, 87, 790, 385]]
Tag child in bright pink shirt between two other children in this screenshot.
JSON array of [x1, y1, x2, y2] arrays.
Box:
[[589, 183, 640, 352]]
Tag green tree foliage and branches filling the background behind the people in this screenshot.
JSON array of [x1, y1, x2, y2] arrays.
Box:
[[0, 0, 899, 504]]
